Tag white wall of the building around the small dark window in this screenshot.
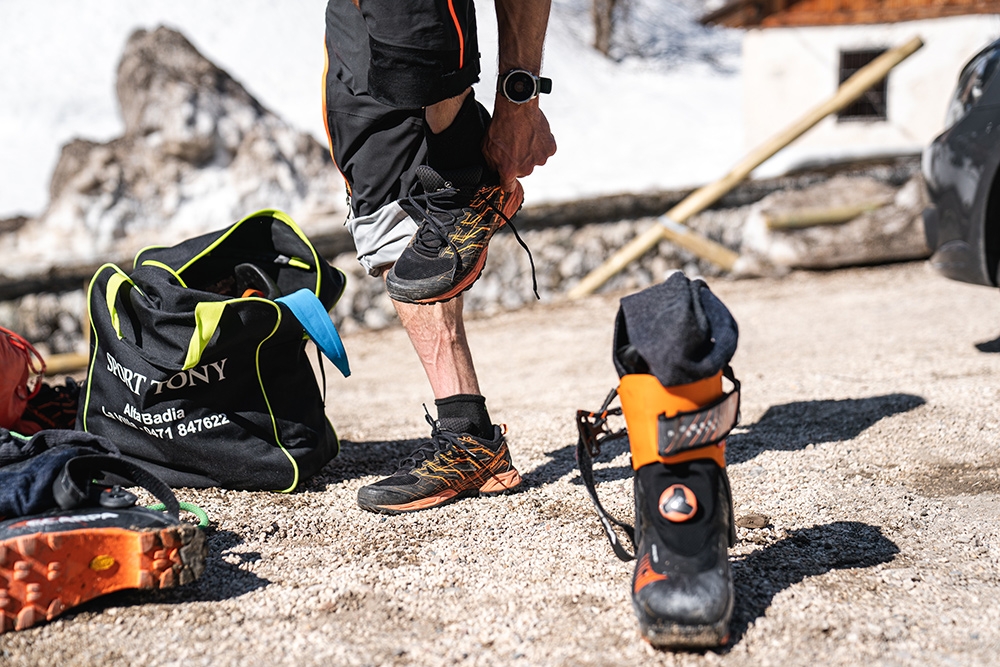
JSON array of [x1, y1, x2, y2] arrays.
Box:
[[743, 14, 1000, 176]]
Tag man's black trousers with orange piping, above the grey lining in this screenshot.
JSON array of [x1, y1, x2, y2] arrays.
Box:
[[324, 0, 480, 219]]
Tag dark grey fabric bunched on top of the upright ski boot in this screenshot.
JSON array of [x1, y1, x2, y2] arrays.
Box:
[[612, 271, 739, 387]]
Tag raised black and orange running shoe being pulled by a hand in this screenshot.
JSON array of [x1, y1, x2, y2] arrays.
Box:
[[385, 165, 534, 303]]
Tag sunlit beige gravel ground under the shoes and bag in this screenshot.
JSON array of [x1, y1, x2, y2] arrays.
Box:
[[0, 263, 1000, 666]]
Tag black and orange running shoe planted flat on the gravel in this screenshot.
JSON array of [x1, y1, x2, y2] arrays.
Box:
[[358, 416, 521, 514]]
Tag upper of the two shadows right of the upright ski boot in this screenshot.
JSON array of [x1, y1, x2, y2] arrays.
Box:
[[726, 394, 926, 464]]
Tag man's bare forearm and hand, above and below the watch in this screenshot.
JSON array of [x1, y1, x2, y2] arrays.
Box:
[[483, 0, 556, 199]]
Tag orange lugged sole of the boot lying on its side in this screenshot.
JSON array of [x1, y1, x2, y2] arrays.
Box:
[[0, 523, 208, 634]]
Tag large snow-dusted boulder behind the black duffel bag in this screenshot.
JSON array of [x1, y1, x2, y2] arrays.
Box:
[[0, 27, 346, 280]]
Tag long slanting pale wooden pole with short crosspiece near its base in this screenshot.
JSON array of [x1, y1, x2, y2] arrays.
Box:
[[569, 37, 924, 299]]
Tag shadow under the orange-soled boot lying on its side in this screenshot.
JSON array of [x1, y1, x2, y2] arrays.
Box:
[[71, 528, 271, 613]]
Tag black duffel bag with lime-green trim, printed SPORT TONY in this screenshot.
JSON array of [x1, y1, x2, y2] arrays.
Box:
[[77, 210, 350, 491]]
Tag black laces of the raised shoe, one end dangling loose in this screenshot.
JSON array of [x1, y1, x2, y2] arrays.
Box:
[[406, 167, 541, 300]]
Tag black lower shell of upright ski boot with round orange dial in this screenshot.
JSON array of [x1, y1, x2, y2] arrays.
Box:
[[632, 459, 735, 648]]
